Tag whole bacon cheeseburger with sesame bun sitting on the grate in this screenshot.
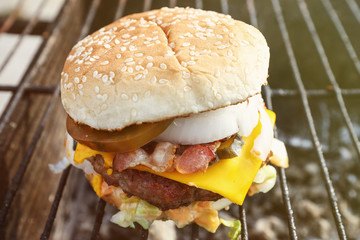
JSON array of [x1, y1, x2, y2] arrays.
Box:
[[61, 8, 287, 238]]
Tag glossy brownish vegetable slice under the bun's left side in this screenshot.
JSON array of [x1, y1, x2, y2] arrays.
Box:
[[66, 116, 173, 153]]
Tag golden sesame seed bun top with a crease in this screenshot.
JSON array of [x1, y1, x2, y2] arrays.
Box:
[[61, 8, 269, 130]]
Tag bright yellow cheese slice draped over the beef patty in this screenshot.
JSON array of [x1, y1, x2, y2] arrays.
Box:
[[74, 110, 275, 205]]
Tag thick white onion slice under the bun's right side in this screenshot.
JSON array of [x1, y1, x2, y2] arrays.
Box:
[[156, 95, 263, 145]]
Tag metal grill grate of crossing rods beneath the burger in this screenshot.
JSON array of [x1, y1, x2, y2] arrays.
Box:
[[0, 0, 360, 239]]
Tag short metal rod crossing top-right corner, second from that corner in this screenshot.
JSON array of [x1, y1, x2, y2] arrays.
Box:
[[321, 0, 360, 74]]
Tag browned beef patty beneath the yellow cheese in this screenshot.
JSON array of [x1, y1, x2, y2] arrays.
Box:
[[87, 155, 221, 211]]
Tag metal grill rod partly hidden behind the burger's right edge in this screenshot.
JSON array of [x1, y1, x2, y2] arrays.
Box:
[[246, 0, 297, 240]]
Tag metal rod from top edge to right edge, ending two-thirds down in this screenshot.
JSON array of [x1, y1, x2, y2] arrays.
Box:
[[297, 0, 360, 158]]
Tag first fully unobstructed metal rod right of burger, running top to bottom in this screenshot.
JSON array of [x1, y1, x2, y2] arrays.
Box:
[[272, 0, 346, 239]]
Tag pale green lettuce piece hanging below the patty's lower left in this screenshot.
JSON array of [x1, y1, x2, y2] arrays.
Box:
[[110, 197, 161, 229]]
